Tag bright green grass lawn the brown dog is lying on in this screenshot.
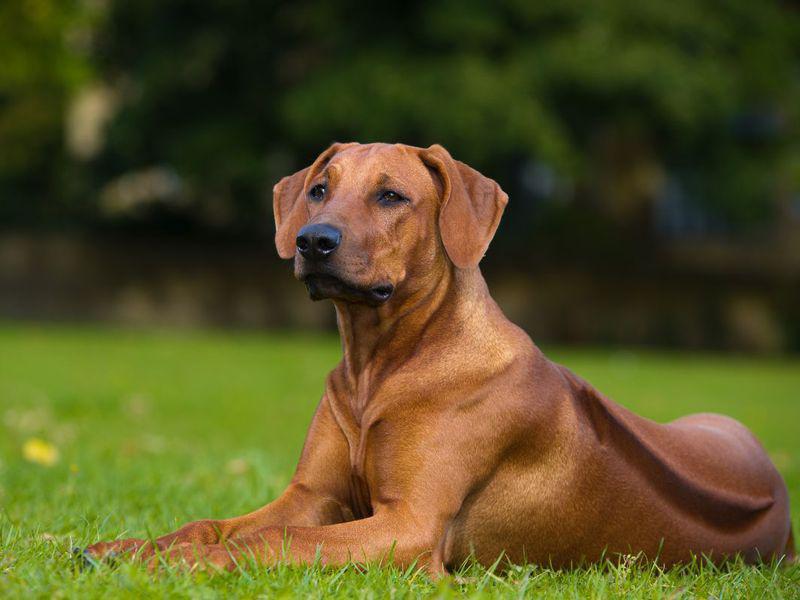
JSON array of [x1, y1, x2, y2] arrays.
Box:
[[0, 325, 800, 598]]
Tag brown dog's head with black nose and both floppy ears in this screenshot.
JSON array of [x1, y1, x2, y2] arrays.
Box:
[[273, 143, 508, 305]]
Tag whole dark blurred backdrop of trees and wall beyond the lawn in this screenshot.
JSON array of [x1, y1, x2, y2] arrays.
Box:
[[0, 0, 800, 353]]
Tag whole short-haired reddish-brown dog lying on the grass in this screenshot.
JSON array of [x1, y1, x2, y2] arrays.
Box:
[[88, 144, 794, 572]]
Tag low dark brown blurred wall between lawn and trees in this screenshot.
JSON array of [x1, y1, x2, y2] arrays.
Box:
[[0, 236, 800, 352]]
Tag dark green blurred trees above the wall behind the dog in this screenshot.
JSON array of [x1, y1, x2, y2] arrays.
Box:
[[0, 0, 800, 246]]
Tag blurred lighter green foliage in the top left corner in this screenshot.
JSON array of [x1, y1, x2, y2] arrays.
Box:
[[0, 0, 93, 223]]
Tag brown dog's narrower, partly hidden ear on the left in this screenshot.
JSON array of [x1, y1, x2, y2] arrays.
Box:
[[272, 142, 355, 259]]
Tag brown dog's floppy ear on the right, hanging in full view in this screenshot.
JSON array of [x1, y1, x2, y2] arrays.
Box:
[[421, 144, 508, 269]]
